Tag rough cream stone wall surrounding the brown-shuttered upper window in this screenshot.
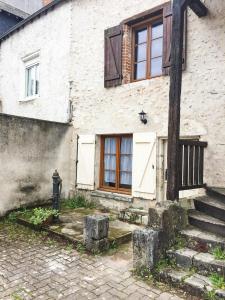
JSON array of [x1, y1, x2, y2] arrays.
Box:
[[71, 0, 225, 186]]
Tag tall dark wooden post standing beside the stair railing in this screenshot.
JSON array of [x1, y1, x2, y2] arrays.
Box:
[[167, 0, 185, 201]]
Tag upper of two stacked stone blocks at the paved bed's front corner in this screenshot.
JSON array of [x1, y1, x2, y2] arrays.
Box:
[[84, 215, 109, 240]]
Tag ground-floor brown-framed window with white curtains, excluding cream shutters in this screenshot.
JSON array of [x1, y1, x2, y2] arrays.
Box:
[[100, 135, 133, 192]]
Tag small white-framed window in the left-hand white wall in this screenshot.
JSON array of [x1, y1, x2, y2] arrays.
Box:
[[25, 63, 39, 98]]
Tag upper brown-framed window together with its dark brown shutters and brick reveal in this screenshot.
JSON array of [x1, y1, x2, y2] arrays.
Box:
[[104, 2, 187, 88]]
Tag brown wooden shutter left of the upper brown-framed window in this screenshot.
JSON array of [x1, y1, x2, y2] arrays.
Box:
[[104, 25, 122, 87]]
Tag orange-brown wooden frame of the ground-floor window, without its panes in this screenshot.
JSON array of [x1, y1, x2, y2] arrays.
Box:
[[99, 134, 133, 195]]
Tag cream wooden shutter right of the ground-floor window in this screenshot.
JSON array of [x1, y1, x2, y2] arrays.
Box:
[[132, 132, 156, 199]]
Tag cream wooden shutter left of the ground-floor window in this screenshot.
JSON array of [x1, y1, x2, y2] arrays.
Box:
[[77, 135, 95, 190]]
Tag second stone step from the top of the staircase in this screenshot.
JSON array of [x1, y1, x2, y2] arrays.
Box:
[[194, 196, 225, 221]]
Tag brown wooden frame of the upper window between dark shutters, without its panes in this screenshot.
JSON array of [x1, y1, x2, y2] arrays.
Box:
[[130, 13, 164, 82]]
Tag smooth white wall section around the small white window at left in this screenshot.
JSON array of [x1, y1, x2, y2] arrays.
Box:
[[0, 1, 71, 122]]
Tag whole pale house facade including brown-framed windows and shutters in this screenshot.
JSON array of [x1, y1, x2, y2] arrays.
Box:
[[0, 0, 225, 208]]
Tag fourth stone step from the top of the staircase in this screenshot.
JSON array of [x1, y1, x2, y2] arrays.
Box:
[[181, 226, 225, 252]]
